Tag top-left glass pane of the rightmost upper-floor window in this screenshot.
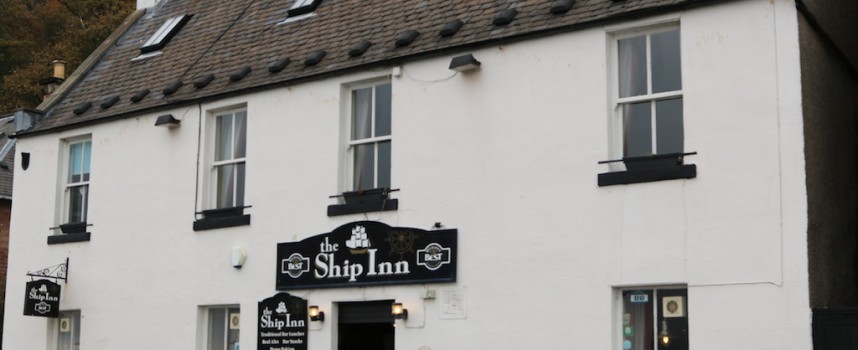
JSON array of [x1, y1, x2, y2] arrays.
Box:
[[618, 35, 647, 97]]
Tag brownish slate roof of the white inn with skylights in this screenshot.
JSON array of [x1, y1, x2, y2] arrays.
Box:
[[26, 0, 715, 136]]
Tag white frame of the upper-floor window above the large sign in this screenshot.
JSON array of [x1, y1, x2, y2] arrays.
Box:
[[341, 76, 394, 192]]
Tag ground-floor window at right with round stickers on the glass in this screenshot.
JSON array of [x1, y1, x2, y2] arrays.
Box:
[[620, 288, 688, 350]]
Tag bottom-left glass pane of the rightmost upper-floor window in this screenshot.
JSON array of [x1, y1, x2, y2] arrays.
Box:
[[623, 102, 652, 158]]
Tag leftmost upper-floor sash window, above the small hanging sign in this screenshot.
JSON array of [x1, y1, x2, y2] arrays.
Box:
[[64, 139, 92, 223]]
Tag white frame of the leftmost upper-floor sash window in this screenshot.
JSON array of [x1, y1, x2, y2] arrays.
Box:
[[57, 135, 92, 224]]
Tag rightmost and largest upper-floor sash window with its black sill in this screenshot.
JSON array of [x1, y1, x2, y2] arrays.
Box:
[[599, 25, 697, 186]]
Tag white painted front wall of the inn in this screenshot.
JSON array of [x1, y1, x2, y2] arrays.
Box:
[[4, 0, 810, 350]]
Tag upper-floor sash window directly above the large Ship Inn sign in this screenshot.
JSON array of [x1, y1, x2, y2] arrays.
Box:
[[348, 81, 392, 191]]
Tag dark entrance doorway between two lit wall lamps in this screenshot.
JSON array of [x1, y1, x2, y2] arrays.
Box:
[[337, 300, 396, 350]]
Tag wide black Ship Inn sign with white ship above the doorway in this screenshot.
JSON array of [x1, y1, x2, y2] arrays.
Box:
[[277, 221, 458, 290]]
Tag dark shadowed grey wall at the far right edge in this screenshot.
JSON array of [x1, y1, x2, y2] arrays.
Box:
[[799, 10, 858, 308]]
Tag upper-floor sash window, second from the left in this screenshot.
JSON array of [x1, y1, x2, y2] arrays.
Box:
[[212, 109, 247, 209]]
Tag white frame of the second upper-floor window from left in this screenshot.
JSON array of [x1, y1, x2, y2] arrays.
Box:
[[202, 105, 250, 210]]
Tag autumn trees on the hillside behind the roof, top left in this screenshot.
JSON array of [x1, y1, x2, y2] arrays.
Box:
[[0, 0, 136, 113]]
